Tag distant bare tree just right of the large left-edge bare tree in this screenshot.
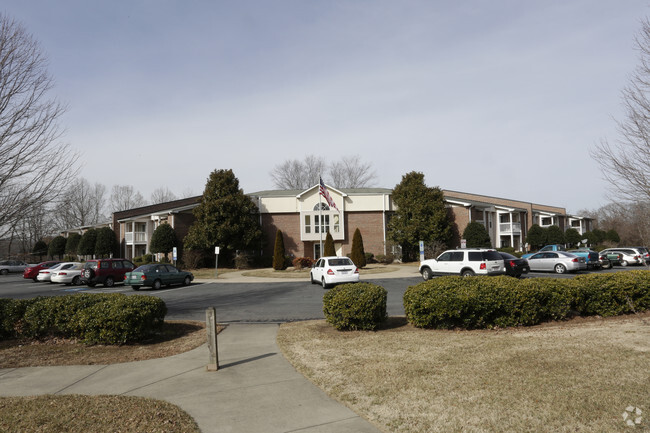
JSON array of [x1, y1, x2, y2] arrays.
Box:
[[54, 178, 106, 229]]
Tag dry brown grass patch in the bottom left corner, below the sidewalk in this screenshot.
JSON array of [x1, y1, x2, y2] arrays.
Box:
[[0, 395, 200, 433]]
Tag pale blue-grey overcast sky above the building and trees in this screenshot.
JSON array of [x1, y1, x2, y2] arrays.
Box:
[[5, 0, 648, 212]]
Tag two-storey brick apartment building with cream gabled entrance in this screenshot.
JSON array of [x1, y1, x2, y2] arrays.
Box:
[[62, 185, 593, 259]]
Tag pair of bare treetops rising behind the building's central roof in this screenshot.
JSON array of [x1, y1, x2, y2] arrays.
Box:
[[271, 155, 376, 189]]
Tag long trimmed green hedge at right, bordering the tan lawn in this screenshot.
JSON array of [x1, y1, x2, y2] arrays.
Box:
[[404, 271, 650, 329]]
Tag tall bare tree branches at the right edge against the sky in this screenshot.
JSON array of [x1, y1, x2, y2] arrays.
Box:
[[591, 18, 650, 201]]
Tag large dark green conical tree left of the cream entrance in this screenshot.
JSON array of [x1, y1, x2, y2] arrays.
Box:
[[185, 170, 262, 264]]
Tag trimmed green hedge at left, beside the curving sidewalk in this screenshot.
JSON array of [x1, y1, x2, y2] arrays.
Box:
[[0, 293, 167, 344]]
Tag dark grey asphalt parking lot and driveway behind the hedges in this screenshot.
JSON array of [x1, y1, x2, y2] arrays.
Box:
[[0, 267, 648, 323]]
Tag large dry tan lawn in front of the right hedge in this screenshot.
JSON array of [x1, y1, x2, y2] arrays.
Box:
[[278, 313, 650, 433]]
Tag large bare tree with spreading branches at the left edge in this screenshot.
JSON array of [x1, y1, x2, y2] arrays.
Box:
[[0, 14, 78, 236]]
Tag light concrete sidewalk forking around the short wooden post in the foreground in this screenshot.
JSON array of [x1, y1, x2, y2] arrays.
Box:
[[0, 324, 379, 433]]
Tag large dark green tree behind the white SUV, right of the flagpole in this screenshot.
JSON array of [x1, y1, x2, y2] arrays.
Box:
[[388, 171, 453, 261]]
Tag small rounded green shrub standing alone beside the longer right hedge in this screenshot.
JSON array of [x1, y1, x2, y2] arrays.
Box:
[[323, 283, 387, 331]]
